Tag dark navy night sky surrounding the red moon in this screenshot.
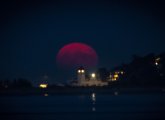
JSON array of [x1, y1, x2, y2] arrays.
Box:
[[0, 0, 165, 83]]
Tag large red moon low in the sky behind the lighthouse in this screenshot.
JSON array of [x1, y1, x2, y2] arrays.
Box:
[[56, 42, 98, 68]]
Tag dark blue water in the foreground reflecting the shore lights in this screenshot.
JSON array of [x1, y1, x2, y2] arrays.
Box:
[[0, 92, 165, 120]]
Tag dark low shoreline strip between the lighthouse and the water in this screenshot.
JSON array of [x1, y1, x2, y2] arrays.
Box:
[[0, 87, 165, 96]]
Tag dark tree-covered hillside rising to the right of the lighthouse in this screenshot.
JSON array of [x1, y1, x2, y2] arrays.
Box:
[[111, 53, 165, 87]]
